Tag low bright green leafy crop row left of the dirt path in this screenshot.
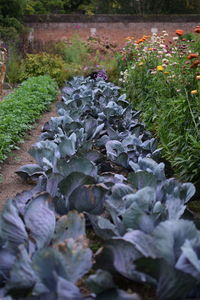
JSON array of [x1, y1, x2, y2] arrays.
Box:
[[0, 76, 58, 161]]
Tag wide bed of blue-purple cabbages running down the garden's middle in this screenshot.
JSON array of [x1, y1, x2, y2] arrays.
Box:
[[0, 77, 200, 300]]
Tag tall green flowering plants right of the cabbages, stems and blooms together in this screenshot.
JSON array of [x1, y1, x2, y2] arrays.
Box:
[[119, 34, 200, 184]]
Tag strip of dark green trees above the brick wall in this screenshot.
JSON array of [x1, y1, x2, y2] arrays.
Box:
[[22, 0, 200, 15]]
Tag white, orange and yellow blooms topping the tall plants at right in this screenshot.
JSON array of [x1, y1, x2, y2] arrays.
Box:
[[119, 26, 200, 95]]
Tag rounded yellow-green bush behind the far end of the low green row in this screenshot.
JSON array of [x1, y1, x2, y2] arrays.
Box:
[[20, 52, 65, 85]]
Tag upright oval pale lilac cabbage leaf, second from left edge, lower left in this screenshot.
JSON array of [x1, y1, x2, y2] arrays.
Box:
[[24, 193, 56, 249]]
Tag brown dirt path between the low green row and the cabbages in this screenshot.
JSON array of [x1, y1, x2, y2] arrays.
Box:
[[0, 98, 57, 211]]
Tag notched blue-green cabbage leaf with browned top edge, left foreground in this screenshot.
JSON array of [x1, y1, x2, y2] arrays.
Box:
[[33, 239, 92, 291]]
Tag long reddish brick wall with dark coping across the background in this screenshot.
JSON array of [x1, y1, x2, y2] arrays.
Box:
[[24, 15, 200, 44]]
